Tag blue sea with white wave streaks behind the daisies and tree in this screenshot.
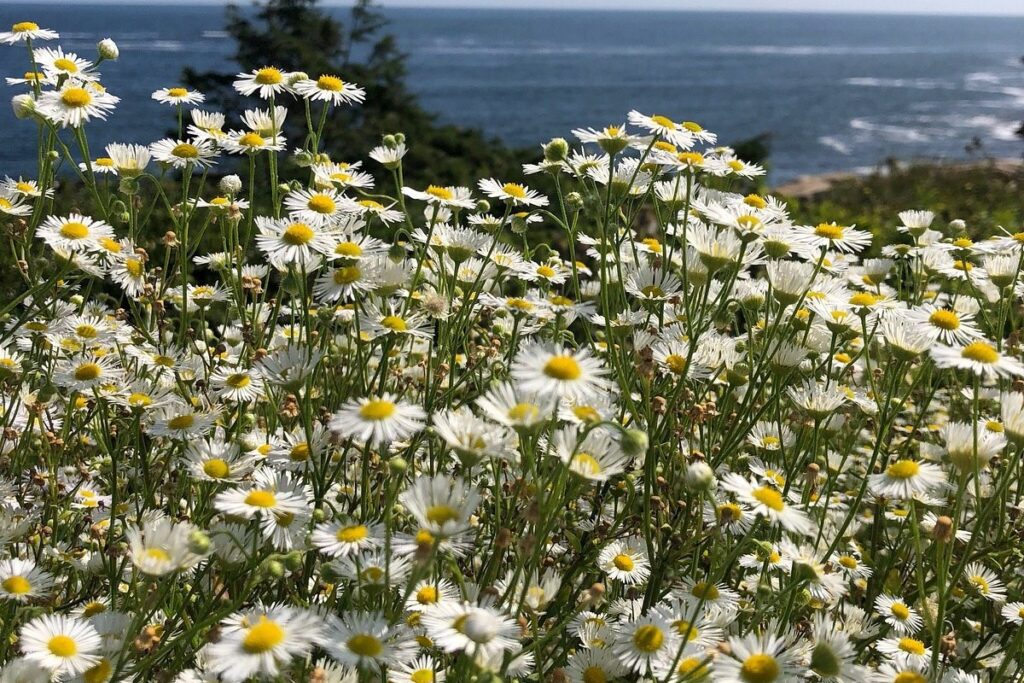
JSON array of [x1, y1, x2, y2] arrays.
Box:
[[0, 1, 1024, 182]]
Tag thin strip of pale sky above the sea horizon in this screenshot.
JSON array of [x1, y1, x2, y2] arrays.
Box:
[[14, 0, 1024, 16]]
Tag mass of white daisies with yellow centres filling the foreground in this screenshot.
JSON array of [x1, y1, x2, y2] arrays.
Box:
[[0, 22, 1024, 683]]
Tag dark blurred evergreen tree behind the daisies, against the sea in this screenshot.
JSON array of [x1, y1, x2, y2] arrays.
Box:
[[184, 0, 535, 185]]
